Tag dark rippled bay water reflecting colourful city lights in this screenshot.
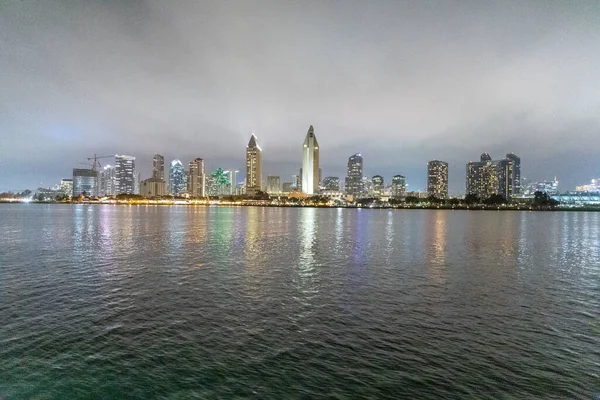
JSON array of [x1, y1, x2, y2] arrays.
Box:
[[0, 204, 600, 400]]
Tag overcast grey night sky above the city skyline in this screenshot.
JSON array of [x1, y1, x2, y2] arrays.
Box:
[[0, 0, 600, 194]]
